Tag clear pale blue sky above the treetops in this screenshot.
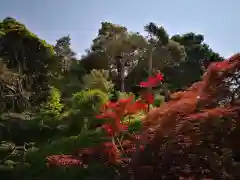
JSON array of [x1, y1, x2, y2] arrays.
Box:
[[0, 0, 240, 57]]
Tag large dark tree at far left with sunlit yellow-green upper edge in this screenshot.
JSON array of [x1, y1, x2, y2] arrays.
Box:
[[0, 18, 56, 109]]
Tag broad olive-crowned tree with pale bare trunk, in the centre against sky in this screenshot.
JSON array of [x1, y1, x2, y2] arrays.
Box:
[[91, 22, 146, 91]]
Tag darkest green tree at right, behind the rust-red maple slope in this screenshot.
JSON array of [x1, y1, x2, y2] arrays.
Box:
[[164, 33, 223, 90]]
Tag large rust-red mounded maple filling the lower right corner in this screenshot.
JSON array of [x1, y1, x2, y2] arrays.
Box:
[[122, 54, 240, 180]]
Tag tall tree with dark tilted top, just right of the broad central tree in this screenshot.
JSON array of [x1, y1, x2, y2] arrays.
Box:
[[127, 23, 186, 94]]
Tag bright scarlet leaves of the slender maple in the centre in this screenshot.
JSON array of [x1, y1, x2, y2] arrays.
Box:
[[94, 73, 163, 161]]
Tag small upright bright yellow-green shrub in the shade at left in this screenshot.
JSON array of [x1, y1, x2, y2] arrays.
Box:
[[40, 87, 64, 122]]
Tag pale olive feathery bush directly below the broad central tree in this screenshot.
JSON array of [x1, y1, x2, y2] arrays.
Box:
[[82, 69, 114, 93]]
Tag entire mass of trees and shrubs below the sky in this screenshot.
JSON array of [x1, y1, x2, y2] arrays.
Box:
[[0, 17, 240, 180]]
